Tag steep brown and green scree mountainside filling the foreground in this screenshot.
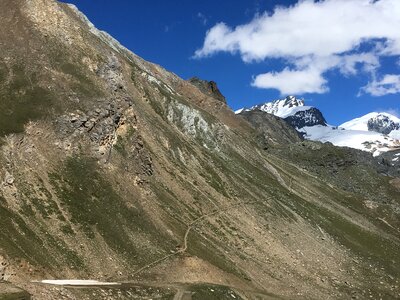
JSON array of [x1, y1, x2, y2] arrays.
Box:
[[0, 0, 400, 299]]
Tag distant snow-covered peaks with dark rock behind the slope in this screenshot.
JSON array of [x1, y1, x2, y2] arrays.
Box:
[[236, 96, 400, 156]]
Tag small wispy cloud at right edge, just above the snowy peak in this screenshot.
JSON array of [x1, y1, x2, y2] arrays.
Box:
[[359, 74, 400, 97]]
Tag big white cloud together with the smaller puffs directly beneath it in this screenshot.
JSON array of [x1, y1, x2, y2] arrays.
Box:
[[195, 0, 400, 93]]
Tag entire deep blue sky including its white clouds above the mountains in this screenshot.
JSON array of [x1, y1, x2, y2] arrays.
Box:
[[60, 0, 400, 125]]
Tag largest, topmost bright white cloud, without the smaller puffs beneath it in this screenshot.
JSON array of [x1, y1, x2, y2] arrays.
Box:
[[196, 0, 400, 61]]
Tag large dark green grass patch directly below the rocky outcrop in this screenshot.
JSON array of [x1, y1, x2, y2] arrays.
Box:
[[50, 156, 173, 261]]
